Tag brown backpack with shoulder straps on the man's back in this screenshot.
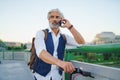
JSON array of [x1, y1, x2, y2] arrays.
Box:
[[28, 29, 66, 73]]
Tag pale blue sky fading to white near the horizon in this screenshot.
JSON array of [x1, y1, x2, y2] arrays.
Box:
[[0, 0, 120, 43]]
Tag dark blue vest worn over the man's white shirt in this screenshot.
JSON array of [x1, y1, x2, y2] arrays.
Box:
[[36, 32, 66, 76]]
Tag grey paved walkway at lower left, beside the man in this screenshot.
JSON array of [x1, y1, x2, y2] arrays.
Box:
[[0, 60, 34, 80]]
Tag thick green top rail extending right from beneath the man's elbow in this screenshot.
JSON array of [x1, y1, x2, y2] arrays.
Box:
[[66, 43, 120, 53]]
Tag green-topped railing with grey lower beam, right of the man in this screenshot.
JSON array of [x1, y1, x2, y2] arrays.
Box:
[[65, 44, 120, 80]]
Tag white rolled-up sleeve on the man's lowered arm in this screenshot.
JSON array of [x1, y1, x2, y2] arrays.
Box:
[[34, 30, 46, 57]]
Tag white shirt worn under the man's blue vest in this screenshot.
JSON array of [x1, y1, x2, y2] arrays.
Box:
[[34, 29, 78, 80]]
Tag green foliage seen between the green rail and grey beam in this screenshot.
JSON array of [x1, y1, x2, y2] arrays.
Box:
[[67, 53, 120, 67]]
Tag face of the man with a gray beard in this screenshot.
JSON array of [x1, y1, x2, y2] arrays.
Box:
[[49, 12, 62, 28]]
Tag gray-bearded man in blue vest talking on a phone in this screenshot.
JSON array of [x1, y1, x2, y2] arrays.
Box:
[[34, 9, 85, 80]]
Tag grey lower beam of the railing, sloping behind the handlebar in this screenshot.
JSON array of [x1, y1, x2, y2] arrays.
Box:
[[71, 60, 120, 80]]
